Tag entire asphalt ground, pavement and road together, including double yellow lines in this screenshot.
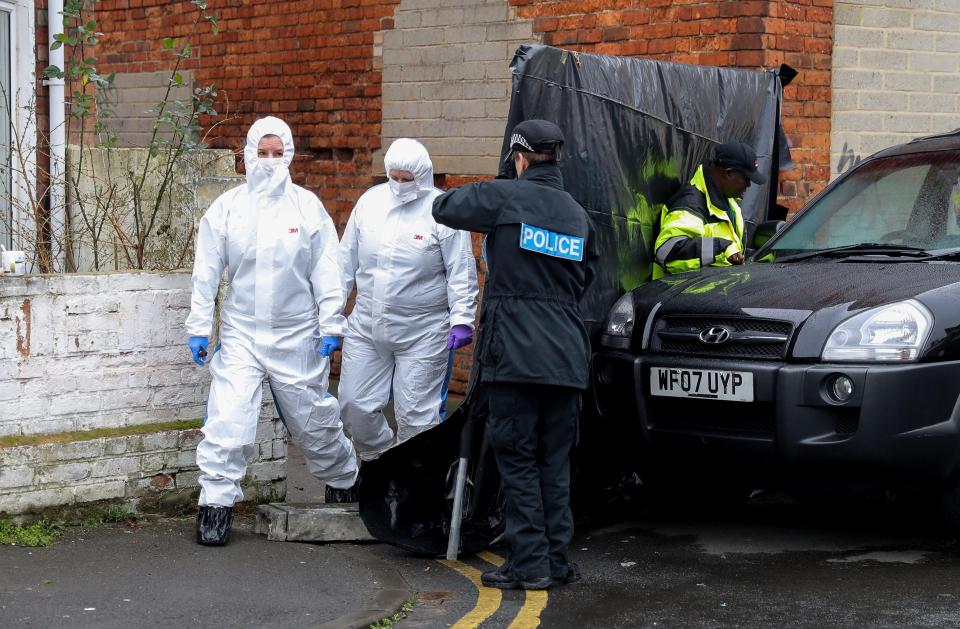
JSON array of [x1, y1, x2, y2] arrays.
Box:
[[7, 442, 960, 629]]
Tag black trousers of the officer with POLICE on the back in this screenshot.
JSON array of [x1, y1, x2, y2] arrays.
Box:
[[486, 383, 580, 579]]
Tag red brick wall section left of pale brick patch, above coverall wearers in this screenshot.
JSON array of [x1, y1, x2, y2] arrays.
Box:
[[97, 0, 399, 229]]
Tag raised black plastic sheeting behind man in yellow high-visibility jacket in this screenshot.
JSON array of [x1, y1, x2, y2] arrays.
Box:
[[500, 46, 795, 327]]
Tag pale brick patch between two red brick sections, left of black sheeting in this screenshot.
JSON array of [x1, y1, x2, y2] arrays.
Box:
[[374, 0, 536, 175]]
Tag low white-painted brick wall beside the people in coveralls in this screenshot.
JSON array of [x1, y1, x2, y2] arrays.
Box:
[[0, 271, 286, 514]]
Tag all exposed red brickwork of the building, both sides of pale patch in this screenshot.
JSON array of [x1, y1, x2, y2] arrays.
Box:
[[37, 0, 833, 391]]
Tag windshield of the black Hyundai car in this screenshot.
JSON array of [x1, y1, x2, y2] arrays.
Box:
[[759, 151, 960, 261]]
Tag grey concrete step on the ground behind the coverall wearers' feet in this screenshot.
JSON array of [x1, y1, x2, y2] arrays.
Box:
[[255, 502, 373, 542]]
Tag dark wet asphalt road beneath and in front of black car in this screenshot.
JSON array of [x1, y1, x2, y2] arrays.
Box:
[[379, 495, 960, 628]]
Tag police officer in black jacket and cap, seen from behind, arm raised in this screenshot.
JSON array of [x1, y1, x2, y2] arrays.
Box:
[[433, 120, 597, 590]]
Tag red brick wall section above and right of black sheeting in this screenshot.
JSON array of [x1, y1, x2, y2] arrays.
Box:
[[510, 0, 833, 210]]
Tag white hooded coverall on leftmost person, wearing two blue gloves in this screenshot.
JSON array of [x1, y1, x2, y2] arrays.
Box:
[[186, 117, 357, 506]]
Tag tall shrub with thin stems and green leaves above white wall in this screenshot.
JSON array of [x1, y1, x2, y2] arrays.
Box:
[[44, 0, 222, 270]]
